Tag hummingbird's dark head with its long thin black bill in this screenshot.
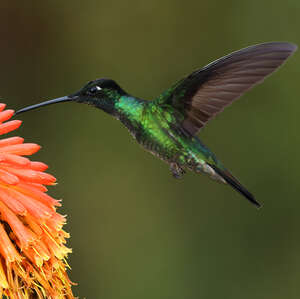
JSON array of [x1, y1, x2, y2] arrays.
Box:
[[15, 79, 127, 114]]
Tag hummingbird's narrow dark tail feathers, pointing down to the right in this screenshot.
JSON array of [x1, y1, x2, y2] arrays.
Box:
[[209, 164, 261, 208]]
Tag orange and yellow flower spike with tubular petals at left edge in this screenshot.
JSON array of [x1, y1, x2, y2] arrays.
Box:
[[0, 104, 74, 299]]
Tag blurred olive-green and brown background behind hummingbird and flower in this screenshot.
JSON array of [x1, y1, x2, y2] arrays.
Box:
[[0, 0, 300, 299]]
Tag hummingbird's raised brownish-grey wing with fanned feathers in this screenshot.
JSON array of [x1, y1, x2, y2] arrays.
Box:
[[158, 42, 297, 135]]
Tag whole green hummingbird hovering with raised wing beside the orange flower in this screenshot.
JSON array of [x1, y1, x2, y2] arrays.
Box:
[[16, 42, 297, 207]]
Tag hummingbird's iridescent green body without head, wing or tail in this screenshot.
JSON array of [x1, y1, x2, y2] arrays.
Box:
[[115, 95, 225, 182]]
